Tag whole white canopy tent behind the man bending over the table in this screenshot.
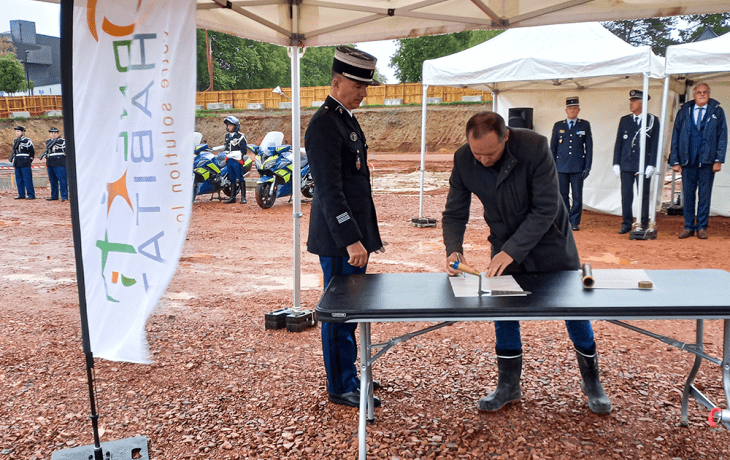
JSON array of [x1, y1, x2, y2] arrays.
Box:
[[421, 23, 676, 225]]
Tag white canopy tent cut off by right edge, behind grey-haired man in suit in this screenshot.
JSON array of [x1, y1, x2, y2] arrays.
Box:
[[666, 34, 730, 217]]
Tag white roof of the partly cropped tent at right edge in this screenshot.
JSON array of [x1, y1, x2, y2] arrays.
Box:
[[666, 33, 730, 75]]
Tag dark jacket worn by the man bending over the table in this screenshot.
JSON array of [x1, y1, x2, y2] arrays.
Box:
[[443, 128, 580, 272]]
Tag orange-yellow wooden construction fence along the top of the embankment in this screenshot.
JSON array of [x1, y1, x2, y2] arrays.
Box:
[[0, 83, 492, 118]]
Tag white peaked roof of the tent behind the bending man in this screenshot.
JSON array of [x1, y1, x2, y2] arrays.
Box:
[[423, 23, 663, 91]]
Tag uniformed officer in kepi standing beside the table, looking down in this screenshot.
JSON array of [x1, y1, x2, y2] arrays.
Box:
[[305, 46, 383, 407]]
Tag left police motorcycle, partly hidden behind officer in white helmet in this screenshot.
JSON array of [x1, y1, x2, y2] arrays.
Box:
[[193, 132, 253, 201]]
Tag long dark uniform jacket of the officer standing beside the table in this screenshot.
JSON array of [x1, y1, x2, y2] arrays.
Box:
[[305, 96, 383, 257]]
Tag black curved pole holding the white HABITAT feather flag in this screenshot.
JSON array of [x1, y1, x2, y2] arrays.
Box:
[[61, 0, 104, 460]]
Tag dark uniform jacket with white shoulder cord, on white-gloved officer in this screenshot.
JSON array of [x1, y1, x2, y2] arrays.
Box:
[[613, 113, 659, 172]]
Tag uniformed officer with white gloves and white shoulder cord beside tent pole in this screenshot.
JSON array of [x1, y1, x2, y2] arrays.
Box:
[[613, 89, 659, 235]]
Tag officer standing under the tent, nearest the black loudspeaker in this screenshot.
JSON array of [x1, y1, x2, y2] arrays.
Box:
[[550, 96, 593, 231]]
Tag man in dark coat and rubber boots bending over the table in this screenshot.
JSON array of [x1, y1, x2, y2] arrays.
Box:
[[443, 112, 611, 414]]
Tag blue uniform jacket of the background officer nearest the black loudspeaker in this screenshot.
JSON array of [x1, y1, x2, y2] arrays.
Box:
[[550, 118, 593, 173]]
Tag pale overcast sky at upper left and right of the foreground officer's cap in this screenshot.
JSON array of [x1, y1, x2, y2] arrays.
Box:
[[0, 0, 396, 83]]
